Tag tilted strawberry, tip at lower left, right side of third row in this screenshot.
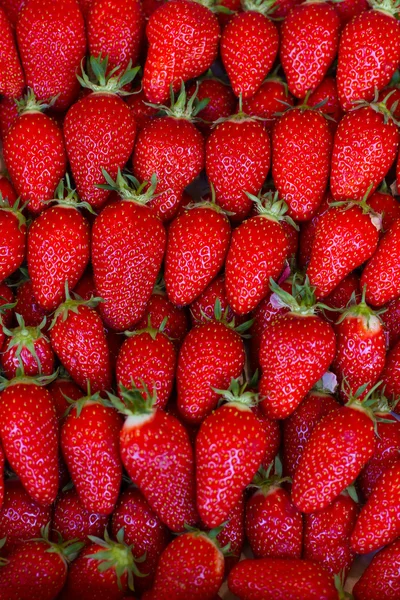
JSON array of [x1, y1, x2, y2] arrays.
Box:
[[307, 203, 380, 302]]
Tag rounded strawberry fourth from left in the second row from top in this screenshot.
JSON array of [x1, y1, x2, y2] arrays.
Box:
[[206, 111, 271, 221]]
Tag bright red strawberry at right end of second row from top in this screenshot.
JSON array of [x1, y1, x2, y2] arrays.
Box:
[[330, 101, 400, 201]]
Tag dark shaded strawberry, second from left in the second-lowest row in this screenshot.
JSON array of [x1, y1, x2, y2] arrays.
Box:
[[52, 489, 108, 544]]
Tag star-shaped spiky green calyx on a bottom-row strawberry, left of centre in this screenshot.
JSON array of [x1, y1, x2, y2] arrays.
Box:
[[87, 527, 148, 591]]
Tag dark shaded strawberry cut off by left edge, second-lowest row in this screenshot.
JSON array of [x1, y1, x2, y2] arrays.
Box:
[[0, 478, 52, 556]]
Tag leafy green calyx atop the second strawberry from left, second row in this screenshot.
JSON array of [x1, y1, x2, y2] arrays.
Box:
[[77, 54, 140, 96]]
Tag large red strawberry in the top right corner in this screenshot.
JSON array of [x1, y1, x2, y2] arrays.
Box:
[[337, 0, 400, 110]]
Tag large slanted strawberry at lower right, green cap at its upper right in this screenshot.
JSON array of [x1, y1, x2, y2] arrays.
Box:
[[292, 388, 375, 513]]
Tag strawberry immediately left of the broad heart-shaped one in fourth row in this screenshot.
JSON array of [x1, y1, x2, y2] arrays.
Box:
[[176, 314, 248, 425]]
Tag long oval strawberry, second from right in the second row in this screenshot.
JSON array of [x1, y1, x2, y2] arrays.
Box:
[[272, 105, 333, 221]]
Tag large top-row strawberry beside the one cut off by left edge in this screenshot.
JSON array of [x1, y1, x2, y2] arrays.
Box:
[[17, 0, 86, 110]]
